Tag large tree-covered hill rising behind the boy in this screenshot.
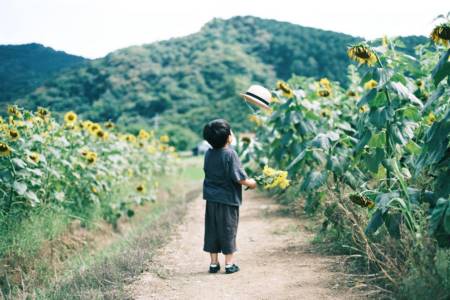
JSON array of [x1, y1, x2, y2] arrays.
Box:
[[17, 17, 426, 149]]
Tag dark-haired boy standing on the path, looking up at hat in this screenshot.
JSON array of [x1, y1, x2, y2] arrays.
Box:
[[203, 119, 256, 274]]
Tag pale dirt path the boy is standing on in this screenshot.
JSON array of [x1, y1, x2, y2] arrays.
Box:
[[129, 192, 352, 300]]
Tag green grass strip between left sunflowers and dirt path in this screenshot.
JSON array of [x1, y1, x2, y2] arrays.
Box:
[[0, 164, 203, 299]]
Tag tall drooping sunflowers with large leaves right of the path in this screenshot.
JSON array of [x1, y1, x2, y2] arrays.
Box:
[[239, 18, 450, 299]]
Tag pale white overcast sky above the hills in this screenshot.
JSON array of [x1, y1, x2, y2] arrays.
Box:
[[0, 0, 450, 58]]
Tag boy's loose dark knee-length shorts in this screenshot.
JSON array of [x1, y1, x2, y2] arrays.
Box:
[[203, 201, 239, 254]]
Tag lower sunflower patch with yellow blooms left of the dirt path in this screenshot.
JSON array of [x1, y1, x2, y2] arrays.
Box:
[[0, 106, 176, 231]]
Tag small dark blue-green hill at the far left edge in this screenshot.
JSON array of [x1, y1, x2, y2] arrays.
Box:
[[0, 43, 85, 104]]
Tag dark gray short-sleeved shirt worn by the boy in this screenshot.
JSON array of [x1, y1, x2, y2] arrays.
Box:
[[203, 147, 248, 206]]
